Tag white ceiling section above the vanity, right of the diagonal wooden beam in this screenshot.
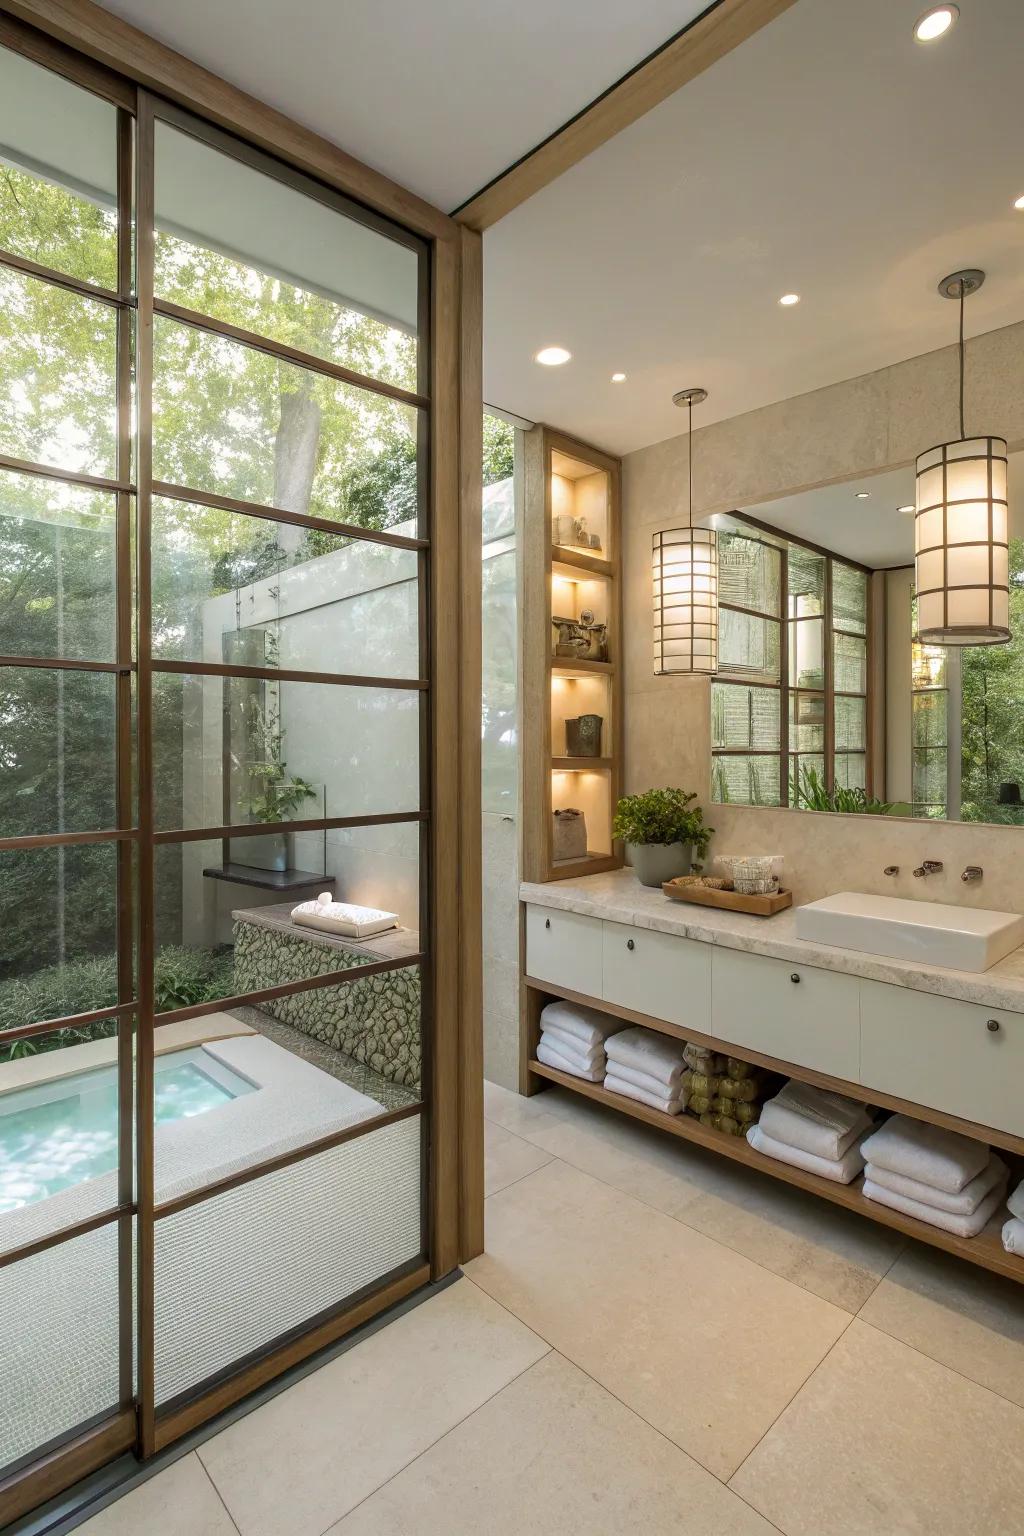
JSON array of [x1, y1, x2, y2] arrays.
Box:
[[484, 0, 1024, 452]]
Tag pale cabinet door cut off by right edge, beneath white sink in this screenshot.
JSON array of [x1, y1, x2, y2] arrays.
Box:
[[861, 982, 1024, 1137]]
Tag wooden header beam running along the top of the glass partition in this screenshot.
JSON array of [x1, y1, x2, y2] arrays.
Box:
[[3, 0, 457, 240]]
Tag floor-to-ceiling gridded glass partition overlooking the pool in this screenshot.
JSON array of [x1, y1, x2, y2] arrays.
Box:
[[0, 36, 431, 1522]]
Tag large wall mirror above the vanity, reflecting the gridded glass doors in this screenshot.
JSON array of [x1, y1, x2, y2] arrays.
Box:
[[709, 448, 1024, 826]]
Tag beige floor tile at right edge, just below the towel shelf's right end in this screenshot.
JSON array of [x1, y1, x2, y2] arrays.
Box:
[[861, 1243, 1024, 1406]]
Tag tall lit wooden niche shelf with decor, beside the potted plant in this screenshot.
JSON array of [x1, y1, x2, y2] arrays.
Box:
[[522, 425, 623, 882]]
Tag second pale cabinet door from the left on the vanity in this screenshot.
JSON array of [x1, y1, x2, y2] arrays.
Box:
[[603, 923, 711, 1034]]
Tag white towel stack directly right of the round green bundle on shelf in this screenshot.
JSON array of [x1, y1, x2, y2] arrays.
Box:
[[746, 1078, 872, 1184]]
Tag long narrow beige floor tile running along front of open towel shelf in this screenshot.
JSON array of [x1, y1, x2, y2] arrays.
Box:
[[530, 1104, 904, 1312]]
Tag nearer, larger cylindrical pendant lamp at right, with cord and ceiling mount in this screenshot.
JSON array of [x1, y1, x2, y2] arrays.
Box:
[[913, 269, 1010, 645]]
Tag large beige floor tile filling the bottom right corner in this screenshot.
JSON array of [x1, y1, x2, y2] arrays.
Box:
[[732, 1321, 1024, 1536]]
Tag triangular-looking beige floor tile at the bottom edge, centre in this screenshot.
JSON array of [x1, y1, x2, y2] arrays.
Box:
[[330, 1353, 772, 1536]]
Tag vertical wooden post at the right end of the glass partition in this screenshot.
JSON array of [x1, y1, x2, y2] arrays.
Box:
[[459, 229, 484, 1264]]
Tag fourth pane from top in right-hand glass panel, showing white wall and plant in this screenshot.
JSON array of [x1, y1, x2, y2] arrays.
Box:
[[154, 674, 421, 835]]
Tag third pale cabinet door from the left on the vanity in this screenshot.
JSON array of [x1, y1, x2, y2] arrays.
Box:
[[711, 948, 860, 1083]]
